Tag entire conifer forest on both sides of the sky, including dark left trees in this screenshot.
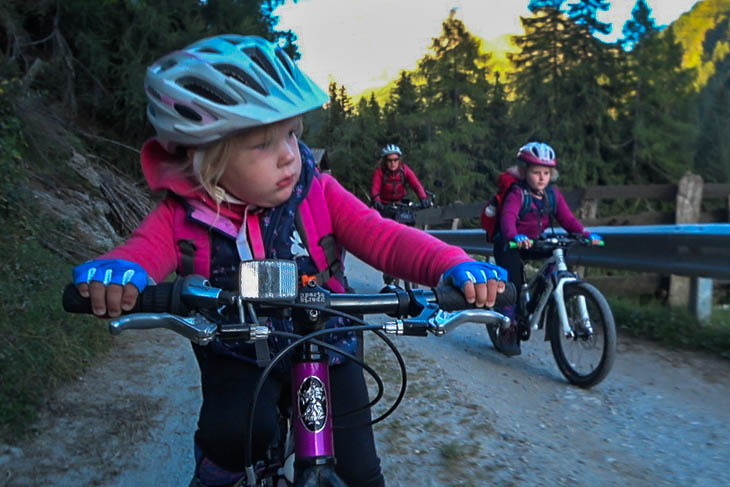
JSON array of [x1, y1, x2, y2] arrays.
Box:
[[0, 0, 730, 203]]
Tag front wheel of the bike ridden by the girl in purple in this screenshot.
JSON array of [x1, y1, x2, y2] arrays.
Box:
[[548, 282, 616, 388]]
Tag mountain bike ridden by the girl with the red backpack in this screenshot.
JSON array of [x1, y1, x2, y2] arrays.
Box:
[[487, 234, 616, 388]]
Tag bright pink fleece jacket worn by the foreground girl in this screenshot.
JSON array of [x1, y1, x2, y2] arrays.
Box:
[[102, 139, 472, 286]]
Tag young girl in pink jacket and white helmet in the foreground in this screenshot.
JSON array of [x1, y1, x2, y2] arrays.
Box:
[[74, 35, 506, 486]]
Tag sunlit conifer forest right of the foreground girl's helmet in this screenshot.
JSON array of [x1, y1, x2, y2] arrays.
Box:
[[310, 0, 730, 203]]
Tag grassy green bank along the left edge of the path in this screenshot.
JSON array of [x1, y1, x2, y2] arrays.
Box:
[[0, 105, 111, 443]]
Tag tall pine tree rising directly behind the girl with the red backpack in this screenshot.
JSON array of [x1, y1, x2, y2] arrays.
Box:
[[510, 2, 613, 186]]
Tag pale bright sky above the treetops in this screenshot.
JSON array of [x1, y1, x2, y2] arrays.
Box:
[[274, 0, 698, 95]]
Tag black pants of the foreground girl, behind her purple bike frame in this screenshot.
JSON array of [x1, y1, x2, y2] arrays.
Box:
[[193, 345, 385, 487]]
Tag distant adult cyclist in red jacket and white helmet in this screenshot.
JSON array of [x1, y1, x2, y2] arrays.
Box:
[[370, 144, 433, 213]]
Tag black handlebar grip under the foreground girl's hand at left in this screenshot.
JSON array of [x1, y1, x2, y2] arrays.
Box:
[[62, 280, 179, 314]]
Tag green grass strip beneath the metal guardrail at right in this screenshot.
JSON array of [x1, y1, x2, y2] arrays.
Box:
[[609, 298, 730, 358]]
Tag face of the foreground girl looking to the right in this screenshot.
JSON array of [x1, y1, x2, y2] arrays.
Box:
[[218, 117, 302, 208]]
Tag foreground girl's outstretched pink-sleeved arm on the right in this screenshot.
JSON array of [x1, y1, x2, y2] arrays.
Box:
[[320, 175, 473, 286]]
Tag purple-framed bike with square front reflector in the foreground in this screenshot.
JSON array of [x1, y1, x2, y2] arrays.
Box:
[[63, 260, 516, 487]]
